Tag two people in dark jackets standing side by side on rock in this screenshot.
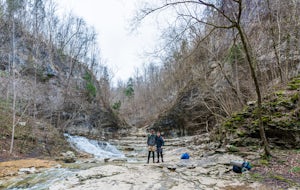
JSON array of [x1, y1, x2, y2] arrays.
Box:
[[147, 129, 165, 164]]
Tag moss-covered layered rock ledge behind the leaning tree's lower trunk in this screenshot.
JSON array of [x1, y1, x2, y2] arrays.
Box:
[[220, 77, 300, 148]]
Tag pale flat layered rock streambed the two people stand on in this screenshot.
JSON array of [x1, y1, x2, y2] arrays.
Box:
[[0, 134, 296, 190]]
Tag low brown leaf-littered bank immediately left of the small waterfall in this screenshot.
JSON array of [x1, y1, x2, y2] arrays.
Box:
[[0, 101, 71, 161]]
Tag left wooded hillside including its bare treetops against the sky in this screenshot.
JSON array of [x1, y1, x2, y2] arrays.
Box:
[[0, 0, 125, 157]]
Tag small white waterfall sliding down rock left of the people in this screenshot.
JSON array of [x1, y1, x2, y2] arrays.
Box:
[[65, 134, 125, 158]]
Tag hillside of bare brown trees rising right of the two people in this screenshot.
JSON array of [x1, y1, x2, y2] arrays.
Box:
[[113, 0, 300, 135]]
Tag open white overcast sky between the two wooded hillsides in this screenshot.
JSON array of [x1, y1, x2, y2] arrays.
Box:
[[56, 0, 159, 84]]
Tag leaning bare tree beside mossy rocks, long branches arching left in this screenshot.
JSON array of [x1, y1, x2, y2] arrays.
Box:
[[137, 0, 271, 156]]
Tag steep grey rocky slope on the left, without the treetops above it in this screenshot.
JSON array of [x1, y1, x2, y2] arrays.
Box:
[[0, 20, 127, 158]]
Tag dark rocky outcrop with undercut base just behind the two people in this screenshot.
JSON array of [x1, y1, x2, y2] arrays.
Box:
[[148, 81, 224, 137]]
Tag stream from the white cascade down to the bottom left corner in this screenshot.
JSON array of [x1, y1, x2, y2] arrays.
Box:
[[0, 134, 125, 190]]
